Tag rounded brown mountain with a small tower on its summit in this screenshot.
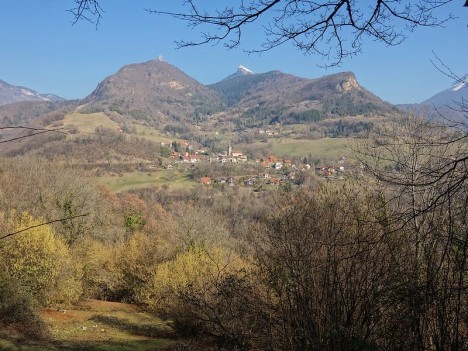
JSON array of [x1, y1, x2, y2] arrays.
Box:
[[86, 56, 225, 125]]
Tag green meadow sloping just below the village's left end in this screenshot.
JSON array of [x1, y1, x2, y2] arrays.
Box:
[[98, 169, 196, 192]]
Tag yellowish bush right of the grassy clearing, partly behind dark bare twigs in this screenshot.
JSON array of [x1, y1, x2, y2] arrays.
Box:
[[146, 244, 252, 346]]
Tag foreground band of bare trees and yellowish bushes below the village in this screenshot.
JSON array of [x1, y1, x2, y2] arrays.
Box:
[[0, 117, 468, 351]]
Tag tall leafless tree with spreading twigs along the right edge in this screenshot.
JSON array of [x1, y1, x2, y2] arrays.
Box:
[[358, 117, 468, 350]]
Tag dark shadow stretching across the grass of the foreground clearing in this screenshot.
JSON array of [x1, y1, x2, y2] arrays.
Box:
[[91, 315, 174, 339]]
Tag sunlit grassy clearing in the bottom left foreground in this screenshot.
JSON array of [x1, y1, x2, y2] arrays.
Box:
[[0, 300, 174, 351]]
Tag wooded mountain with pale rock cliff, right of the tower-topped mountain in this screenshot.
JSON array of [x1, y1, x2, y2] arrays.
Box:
[[210, 71, 394, 127]]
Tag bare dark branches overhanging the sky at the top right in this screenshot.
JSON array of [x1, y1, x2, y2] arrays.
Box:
[[147, 0, 453, 65]]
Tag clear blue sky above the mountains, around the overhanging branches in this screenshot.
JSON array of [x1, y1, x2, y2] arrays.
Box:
[[0, 0, 468, 103]]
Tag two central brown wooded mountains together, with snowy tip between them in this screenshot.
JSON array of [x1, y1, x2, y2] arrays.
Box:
[[76, 59, 395, 129]]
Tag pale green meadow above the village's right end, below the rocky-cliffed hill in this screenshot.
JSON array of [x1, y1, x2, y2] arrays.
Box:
[[268, 138, 352, 158]]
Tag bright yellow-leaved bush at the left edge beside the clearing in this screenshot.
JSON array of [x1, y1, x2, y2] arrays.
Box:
[[0, 212, 81, 304]]
